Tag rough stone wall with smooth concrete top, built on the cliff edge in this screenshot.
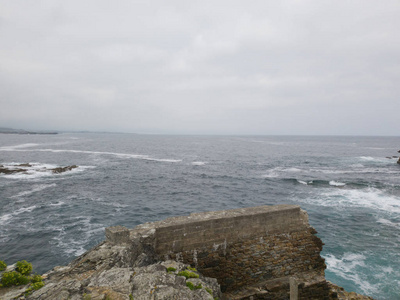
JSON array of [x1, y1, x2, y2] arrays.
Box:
[[106, 205, 332, 299]]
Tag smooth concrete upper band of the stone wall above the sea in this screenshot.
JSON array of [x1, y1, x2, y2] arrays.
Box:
[[156, 205, 308, 254]]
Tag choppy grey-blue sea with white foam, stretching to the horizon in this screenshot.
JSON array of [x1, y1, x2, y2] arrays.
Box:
[[0, 133, 400, 299]]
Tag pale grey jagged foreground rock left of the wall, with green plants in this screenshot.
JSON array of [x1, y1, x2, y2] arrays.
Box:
[[0, 242, 221, 300]]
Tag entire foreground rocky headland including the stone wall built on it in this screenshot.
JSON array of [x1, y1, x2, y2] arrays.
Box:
[[0, 205, 372, 300]]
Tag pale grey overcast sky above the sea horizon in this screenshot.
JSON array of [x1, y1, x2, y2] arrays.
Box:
[[0, 0, 400, 135]]
